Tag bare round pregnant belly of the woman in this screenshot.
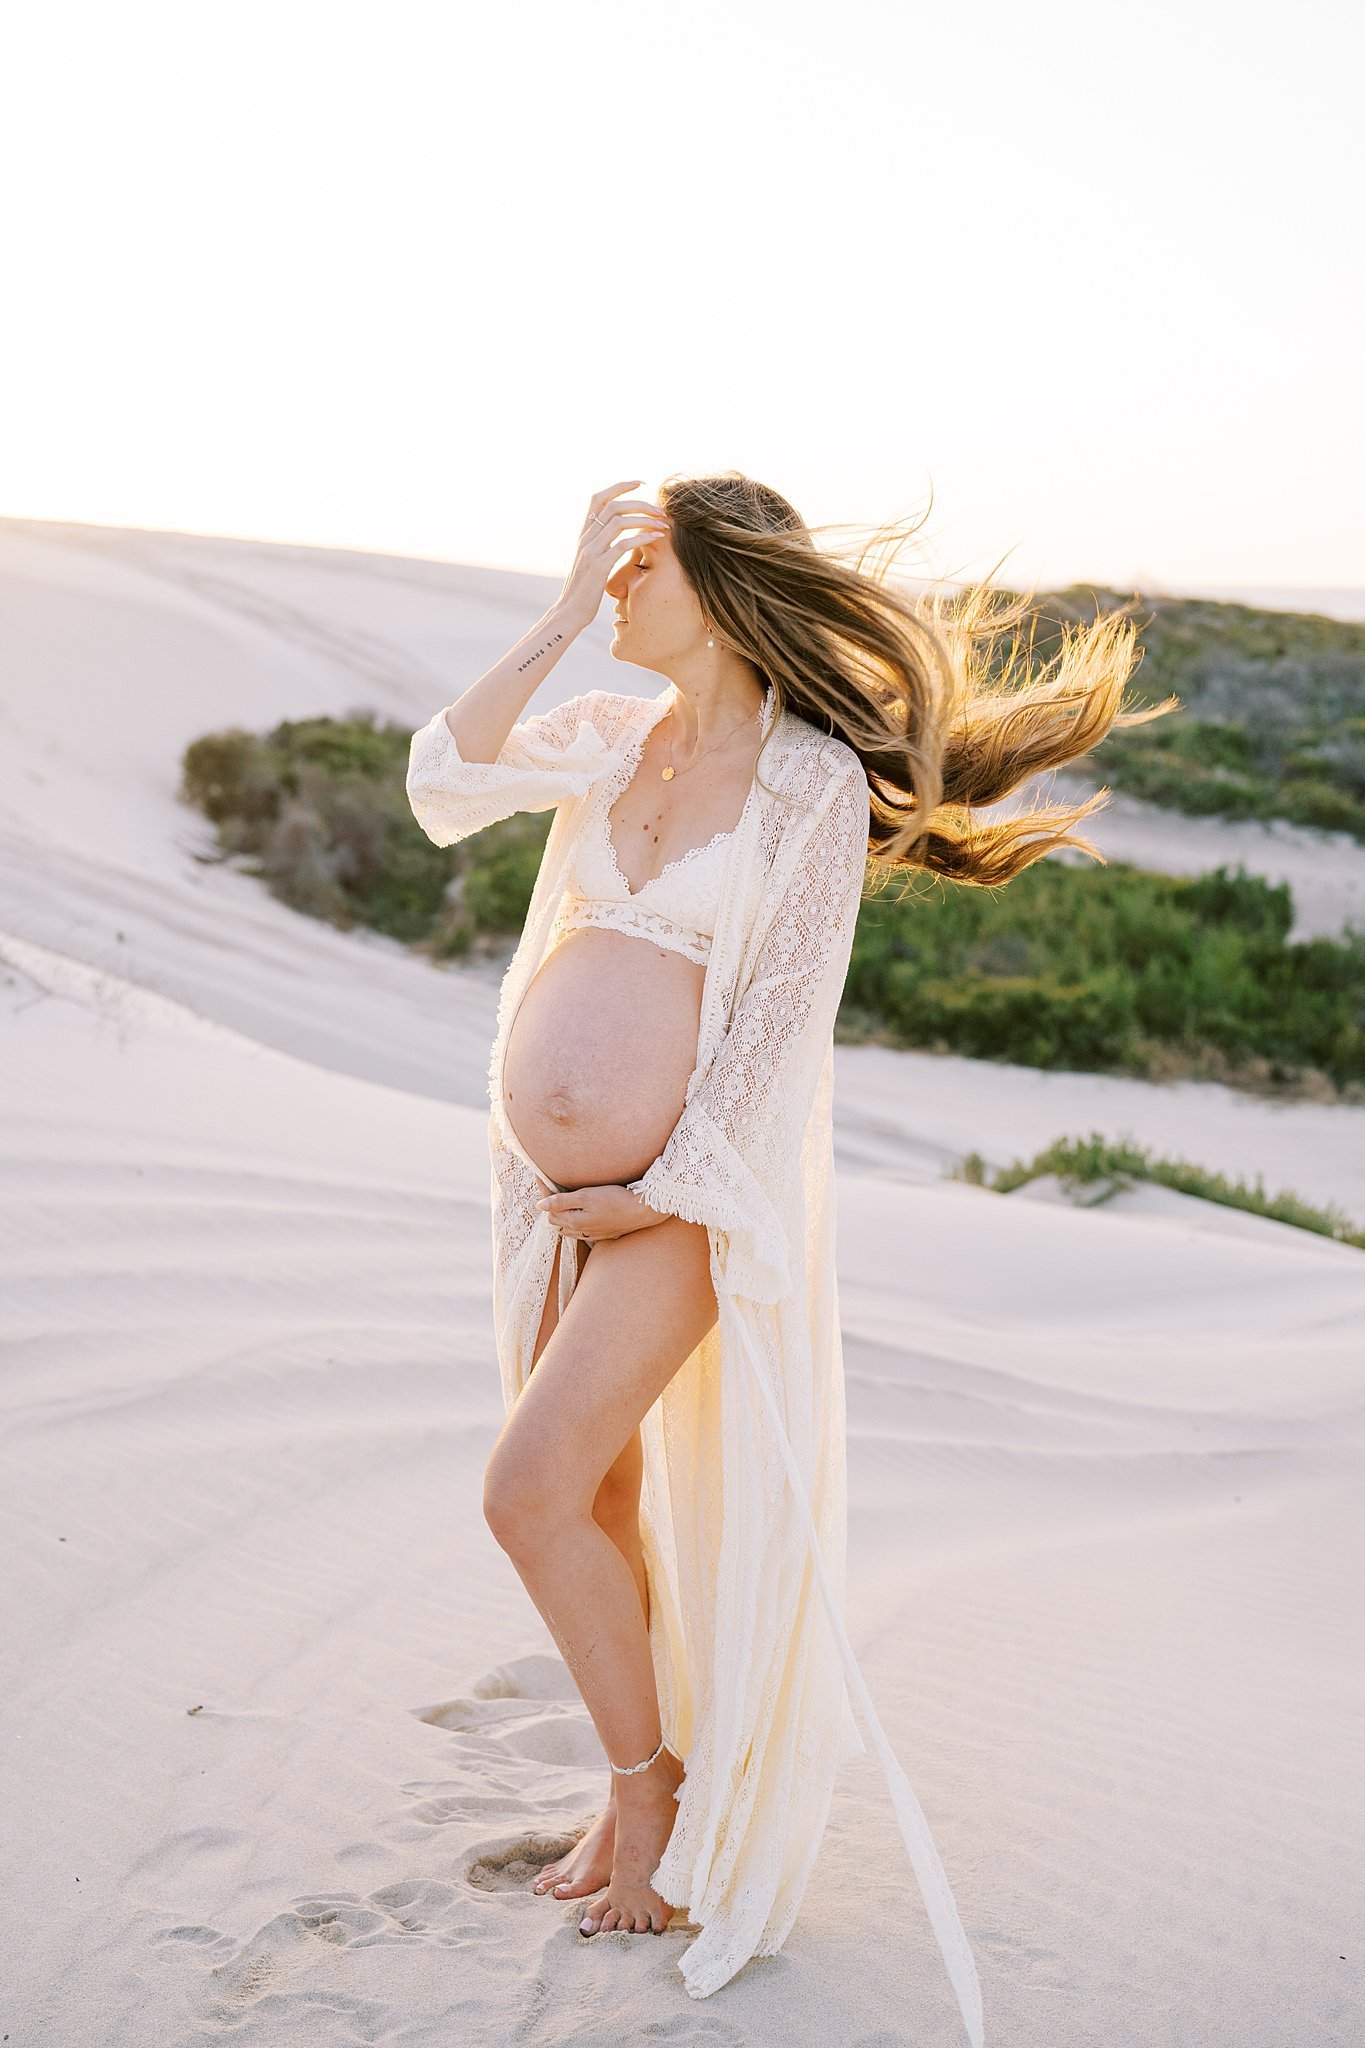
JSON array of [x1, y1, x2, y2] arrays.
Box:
[[501, 926, 706, 1188]]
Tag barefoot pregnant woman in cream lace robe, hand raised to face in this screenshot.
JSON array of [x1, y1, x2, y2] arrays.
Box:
[[407, 473, 1173, 2044]]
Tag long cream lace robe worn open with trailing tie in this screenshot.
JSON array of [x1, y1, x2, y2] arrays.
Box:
[[407, 686, 982, 2048]]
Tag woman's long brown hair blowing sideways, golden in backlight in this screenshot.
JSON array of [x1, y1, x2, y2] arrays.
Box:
[[659, 471, 1181, 887]]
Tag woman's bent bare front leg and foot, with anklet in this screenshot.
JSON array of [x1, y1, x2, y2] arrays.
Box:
[[483, 1217, 716, 1933]]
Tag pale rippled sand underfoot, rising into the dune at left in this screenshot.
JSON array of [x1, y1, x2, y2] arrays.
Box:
[[0, 522, 1365, 2048]]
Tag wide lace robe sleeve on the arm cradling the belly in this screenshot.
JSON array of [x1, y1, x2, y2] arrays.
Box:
[[628, 758, 868, 1303]]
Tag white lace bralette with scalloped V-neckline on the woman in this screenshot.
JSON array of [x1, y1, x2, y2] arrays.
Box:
[[557, 782, 739, 963]]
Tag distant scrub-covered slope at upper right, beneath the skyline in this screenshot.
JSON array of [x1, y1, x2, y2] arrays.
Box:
[[1019, 586, 1365, 842]]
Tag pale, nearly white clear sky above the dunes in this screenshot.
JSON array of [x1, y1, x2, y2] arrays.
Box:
[[0, 0, 1365, 590]]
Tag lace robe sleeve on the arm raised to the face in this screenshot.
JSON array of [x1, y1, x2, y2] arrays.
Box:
[[407, 690, 628, 846]]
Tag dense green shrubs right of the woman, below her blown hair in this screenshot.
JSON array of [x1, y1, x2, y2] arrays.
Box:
[[841, 858, 1365, 1087]]
